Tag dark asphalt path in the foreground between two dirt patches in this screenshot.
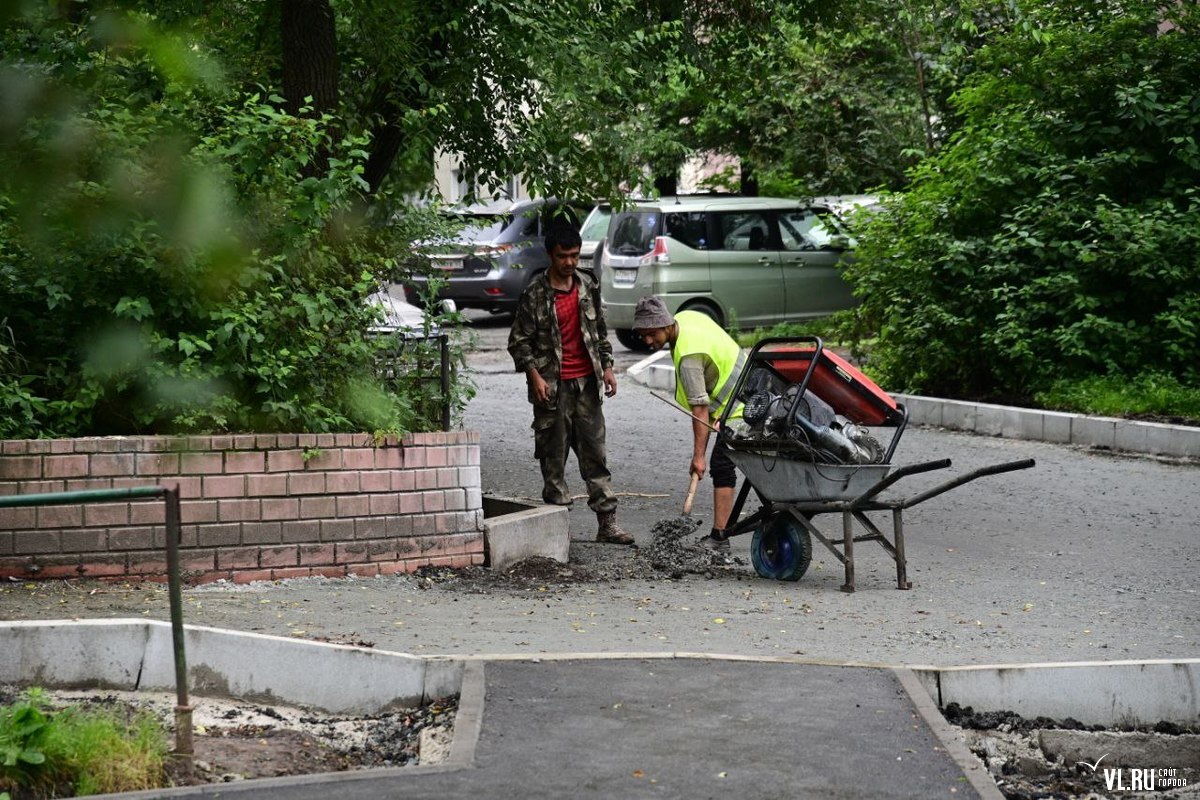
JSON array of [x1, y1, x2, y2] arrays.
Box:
[[105, 658, 1001, 800]]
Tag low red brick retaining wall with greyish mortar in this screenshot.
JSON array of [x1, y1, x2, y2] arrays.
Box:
[[0, 432, 484, 583]]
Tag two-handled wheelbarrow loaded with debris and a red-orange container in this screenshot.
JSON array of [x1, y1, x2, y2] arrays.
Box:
[[716, 337, 1034, 591]]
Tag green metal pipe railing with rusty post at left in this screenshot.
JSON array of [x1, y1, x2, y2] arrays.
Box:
[[0, 486, 194, 766]]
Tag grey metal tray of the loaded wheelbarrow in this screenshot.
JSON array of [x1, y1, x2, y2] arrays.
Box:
[[728, 447, 892, 503]]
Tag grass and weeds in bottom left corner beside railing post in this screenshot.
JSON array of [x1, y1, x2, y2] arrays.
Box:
[[0, 688, 169, 800]]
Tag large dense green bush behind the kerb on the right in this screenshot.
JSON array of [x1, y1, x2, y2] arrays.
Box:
[[847, 0, 1200, 399]]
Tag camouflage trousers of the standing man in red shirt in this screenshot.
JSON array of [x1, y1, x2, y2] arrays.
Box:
[[533, 375, 617, 513]]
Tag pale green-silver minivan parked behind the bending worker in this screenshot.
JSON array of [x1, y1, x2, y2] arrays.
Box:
[[598, 196, 872, 350]]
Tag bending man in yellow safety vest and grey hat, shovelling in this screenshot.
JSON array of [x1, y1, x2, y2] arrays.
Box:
[[634, 296, 746, 557]]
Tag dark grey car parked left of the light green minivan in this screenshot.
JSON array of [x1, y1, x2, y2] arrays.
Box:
[[406, 198, 588, 313]]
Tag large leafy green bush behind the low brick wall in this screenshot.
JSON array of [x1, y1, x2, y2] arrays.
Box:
[[0, 6, 460, 437]]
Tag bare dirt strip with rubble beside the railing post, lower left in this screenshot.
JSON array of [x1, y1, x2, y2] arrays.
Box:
[[0, 686, 458, 800]]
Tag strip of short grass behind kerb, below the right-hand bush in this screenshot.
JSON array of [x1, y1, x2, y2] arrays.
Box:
[[1034, 373, 1200, 423]]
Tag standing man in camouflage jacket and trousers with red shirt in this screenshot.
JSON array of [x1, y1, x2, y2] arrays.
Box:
[[509, 223, 634, 545]]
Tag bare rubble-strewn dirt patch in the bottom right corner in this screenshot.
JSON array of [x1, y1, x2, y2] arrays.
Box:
[[943, 703, 1200, 800]]
